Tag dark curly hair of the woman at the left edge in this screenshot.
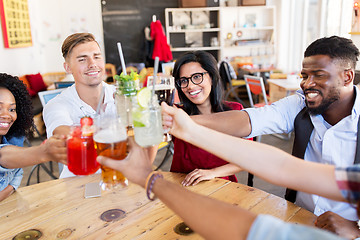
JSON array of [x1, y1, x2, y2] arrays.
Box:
[[0, 73, 34, 139]]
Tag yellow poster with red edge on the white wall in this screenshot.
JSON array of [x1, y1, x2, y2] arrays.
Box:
[[0, 0, 32, 48]]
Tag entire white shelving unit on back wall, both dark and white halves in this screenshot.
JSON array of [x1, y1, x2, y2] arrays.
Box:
[[165, 6, 276, 67]]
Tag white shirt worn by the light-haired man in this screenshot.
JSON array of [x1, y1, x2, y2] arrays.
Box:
[[43, 82, 116, 178]]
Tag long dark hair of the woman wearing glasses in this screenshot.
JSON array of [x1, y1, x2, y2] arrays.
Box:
[[173, 51, 231, 115]]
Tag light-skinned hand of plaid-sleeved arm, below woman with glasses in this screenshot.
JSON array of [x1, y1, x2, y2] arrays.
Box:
[[161, 102, 196, 140]]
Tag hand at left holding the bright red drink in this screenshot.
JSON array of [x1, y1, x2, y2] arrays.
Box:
[[40, 135, 67, 165]]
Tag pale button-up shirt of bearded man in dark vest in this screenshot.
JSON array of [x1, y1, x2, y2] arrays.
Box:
[[245, 87, 360, 220]]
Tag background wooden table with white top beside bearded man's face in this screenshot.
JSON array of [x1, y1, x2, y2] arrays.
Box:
[[267, 79, 301, 102]]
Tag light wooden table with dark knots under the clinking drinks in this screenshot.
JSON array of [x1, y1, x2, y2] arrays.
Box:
[[0, 172, 315, 239]]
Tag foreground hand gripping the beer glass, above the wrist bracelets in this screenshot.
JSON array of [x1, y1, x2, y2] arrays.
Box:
[[97, 137, 152, 187]]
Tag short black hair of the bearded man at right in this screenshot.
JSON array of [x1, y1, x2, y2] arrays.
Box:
[[304, 36, 359, 69]]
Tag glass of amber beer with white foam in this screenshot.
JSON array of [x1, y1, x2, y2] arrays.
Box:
[[94, 116, 128, 190]]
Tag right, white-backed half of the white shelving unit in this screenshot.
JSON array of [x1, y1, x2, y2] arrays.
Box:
[[219, 6, 276, 67]]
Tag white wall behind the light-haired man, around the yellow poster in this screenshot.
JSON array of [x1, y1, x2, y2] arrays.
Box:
[[0, 0, 104, 76]]
